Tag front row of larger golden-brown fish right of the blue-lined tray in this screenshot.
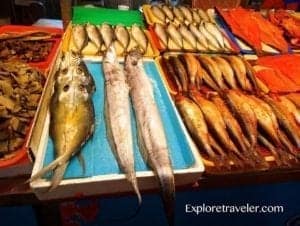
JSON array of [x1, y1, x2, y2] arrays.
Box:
[[175, 89, 300, 170]]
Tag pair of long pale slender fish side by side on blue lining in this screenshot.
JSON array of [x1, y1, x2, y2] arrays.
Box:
[[103, 46, 175, 225]]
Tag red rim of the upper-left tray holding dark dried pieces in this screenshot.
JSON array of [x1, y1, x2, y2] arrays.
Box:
[[0, 25, 63, 73]]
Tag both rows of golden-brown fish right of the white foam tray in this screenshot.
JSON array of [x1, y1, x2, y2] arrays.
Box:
[[163, 54, 300, 170]]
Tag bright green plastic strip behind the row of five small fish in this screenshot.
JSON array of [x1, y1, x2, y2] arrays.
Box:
[[72, 6, 144, 27]]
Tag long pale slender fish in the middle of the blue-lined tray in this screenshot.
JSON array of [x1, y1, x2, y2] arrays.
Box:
[[103, 46, 142, 205]]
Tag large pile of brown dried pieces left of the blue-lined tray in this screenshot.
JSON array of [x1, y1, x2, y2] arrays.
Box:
[[0, 63, 45, 158]]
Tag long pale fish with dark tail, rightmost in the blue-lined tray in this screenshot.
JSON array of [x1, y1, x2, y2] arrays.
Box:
[[125, 51, 175, 225]]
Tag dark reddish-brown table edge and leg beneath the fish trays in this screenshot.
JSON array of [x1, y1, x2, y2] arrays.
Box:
[[0, 169, 300, 226]]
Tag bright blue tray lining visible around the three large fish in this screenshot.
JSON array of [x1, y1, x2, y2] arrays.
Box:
[[44, 61, 195, 178]]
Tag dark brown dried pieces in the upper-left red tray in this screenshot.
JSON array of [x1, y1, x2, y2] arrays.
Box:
[[0, 31, 56, 63]]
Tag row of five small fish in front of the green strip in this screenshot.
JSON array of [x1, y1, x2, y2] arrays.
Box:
[[72, 23, 151, 55]]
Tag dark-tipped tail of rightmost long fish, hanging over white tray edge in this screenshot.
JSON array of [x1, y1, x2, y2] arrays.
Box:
[[157, 164, 175, 226]]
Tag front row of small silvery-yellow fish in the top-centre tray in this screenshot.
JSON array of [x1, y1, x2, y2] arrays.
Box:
[[154, 21, 233, 53]]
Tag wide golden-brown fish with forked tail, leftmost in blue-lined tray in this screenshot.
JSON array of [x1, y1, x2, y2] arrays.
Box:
[[29, 52, 95, 190]]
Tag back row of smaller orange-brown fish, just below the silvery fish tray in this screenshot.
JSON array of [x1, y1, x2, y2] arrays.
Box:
[[162, 54, 268, 92]]
